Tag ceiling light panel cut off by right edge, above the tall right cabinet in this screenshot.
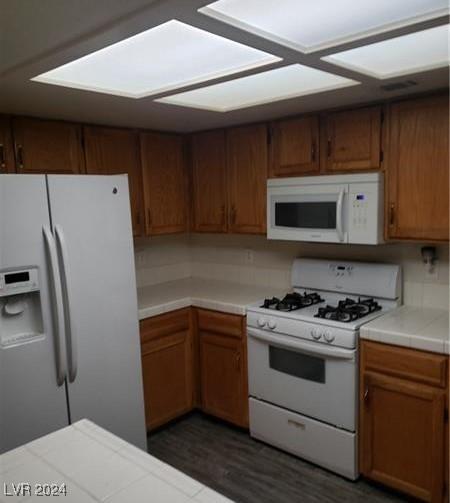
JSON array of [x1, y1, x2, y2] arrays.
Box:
[[322, 25, 449, 79]]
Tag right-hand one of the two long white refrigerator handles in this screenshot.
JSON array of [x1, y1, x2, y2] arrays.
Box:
[[55, 225, 78, 382]]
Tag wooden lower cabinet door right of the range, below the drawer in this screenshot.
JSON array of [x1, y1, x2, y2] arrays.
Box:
[[360, 372, 445, 502]]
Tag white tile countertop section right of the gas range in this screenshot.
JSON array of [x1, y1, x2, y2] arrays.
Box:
[[360, 306, 450, 354]]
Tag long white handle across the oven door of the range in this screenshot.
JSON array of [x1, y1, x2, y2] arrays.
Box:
[[247, 327, 356, 361]]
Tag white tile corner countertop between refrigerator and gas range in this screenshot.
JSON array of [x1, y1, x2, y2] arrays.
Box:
[[138, 278, 285, 320]]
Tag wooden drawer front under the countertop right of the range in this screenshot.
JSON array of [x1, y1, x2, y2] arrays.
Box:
[[361, 341, 448, 388]]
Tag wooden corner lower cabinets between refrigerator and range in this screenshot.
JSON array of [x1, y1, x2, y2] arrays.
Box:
[[140, 308, 248, 430]]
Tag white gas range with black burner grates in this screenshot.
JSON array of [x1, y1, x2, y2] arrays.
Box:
[[247, 259, 401, 479]]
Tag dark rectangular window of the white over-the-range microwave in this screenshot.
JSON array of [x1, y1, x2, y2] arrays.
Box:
[[275, 201, 336, 229]]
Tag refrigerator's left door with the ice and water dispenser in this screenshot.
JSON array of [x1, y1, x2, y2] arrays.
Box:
[[0, 175, 68, 453]]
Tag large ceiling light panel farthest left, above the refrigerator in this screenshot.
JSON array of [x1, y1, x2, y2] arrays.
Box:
[[31, 19, 280, 98]]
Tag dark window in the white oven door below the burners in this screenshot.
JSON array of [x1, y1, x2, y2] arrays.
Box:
[[269, 346, 325, 383]]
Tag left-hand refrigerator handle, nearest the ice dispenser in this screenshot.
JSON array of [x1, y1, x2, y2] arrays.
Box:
[[42, 226, 66, 386]]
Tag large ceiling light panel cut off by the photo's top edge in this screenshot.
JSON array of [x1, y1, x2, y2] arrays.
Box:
[[199, 0, 449, 52]]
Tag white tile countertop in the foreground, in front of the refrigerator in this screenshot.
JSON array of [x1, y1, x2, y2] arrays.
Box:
[[0, 419, 232, 503]]
